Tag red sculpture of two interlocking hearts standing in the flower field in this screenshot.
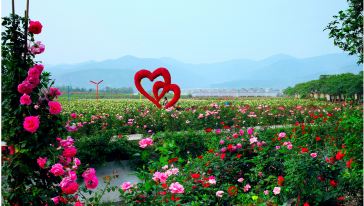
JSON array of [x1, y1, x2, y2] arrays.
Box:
[[134, 67, 181, 108]]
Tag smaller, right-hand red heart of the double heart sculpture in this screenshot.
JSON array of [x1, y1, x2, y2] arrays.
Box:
[[153, 81, 181, 109]]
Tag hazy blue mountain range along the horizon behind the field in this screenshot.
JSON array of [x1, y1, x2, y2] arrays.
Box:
[[46, 54, 362, 89]]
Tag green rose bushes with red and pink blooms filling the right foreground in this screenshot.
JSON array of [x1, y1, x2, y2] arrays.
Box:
[[119, 105, 363, 205]]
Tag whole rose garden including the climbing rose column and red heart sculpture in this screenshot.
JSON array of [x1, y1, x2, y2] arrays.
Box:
[[2, 2, 363, 206]]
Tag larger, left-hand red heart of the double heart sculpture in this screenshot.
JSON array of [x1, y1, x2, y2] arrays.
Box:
[[134, 67, 171, 108]]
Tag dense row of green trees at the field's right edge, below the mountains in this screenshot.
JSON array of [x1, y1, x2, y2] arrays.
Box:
[[283, 71, 363, 98]]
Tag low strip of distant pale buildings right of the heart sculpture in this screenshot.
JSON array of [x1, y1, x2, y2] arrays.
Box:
[[181, 88, 282, 97]]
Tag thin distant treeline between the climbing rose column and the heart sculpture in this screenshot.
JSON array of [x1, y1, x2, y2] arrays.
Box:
[[58, 86, 134, 94]]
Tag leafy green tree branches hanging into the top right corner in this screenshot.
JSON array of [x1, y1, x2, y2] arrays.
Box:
[[325, 0, 363, 64]]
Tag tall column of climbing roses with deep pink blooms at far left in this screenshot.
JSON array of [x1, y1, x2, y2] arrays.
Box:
[[2, 15, 98, 206]]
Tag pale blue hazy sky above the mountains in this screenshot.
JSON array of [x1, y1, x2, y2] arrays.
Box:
[[1, 0, 347, 64]]
